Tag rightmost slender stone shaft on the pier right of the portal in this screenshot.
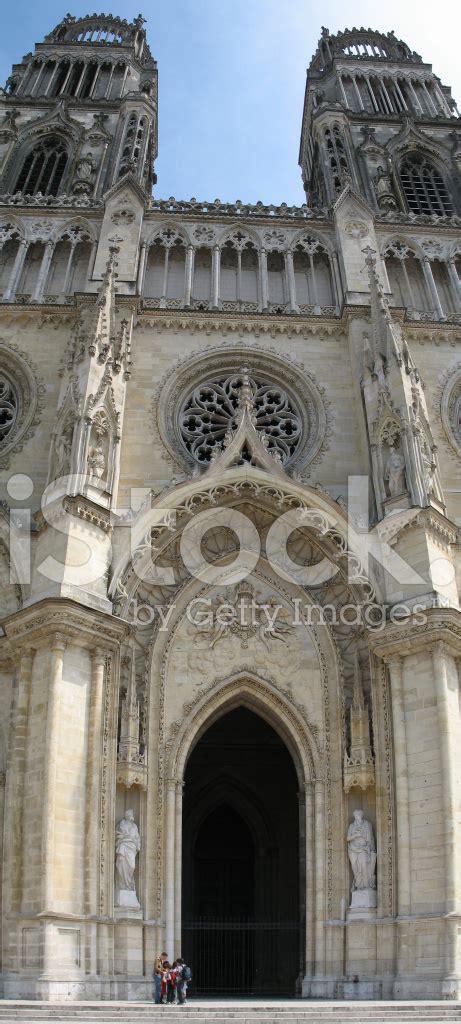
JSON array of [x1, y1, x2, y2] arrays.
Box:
[[432, 641, 459, 913]]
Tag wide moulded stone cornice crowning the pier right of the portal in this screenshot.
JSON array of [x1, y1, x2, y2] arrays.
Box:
[[368, 608, 461, 660]]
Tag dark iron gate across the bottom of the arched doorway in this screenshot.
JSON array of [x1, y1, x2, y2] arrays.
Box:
[[182, 918, 301, 996]]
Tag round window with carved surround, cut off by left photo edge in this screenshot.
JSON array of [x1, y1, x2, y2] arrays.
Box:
[[0, 341, 45, 469]]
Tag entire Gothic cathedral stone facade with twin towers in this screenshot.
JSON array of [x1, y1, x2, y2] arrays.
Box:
[[0, 14, 461, 999]]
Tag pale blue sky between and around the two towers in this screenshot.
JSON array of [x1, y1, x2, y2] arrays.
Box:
[[0, 0, 461, 204]]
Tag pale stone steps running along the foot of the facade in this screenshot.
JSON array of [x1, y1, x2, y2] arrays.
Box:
[[0, 999, 461, 1024]]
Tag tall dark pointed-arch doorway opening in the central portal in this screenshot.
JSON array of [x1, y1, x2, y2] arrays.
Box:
[[182, 708, 302, 995]]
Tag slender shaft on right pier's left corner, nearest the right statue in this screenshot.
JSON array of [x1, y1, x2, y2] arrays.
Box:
[[387, 655, 411, 916]]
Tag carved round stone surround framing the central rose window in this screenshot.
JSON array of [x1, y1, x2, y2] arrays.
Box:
[[154, 344, 329, 475]]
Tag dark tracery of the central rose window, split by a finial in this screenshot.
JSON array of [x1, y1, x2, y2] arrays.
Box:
[[179, 374, 301, 464]]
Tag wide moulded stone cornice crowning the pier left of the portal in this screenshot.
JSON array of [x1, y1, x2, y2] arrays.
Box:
[[2, 598, 129, 652]]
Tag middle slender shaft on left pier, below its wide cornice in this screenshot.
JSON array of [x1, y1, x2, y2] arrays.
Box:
[[42, 634, 66, 911]]
